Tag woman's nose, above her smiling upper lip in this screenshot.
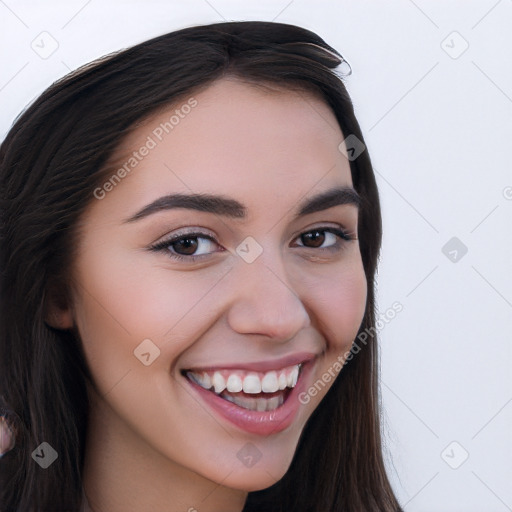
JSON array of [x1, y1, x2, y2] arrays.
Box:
[[227, 251, 311, 342]]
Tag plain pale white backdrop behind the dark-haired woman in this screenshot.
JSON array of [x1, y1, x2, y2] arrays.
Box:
[[0, 0, 512, 512]]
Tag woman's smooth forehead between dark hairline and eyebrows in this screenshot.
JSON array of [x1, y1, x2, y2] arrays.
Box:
[[95, 79, 352, 217]]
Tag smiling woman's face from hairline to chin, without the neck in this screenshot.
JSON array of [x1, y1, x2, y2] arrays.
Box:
[[70, 79, 366, 491]]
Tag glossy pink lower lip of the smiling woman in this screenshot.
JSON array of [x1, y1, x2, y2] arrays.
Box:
[[184, 361, 312, 436]]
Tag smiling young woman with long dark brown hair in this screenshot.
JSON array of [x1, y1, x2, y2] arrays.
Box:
[[0, 22, 400, 512]]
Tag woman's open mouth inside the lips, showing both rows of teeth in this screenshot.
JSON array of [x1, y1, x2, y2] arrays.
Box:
[[181, 363, 303, 412]]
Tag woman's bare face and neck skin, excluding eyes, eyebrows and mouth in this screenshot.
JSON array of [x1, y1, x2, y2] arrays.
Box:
[[52, 78, 367, 512]]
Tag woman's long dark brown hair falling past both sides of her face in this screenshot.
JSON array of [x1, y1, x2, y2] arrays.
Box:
[[0, 21, 400, 512]]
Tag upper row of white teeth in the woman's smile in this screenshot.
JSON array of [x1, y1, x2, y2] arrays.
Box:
[[187, 364, 302, 394]]
